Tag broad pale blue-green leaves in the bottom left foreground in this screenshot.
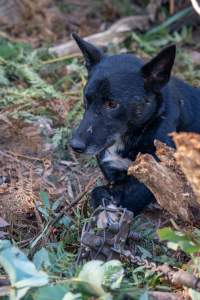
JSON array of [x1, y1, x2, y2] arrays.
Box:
[[0, 241, 147, 300]]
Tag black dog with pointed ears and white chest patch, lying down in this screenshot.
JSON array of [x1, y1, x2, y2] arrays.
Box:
[[70, 34, 200, 214]]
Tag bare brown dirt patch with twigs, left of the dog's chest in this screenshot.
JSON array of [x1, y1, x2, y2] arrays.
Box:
[[0, 117, 100, 241]]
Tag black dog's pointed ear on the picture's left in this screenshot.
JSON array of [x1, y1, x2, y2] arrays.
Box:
[[72, 33, 104, 71]]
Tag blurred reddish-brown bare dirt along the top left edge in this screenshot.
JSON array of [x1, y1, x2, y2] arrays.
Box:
[[0, 0, 132, 47]]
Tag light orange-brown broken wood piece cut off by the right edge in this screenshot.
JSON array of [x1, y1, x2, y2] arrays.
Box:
[[173, 133, 200, 204]]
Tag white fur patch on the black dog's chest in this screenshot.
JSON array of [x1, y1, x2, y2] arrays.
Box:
[[101, 139, 131, 170]]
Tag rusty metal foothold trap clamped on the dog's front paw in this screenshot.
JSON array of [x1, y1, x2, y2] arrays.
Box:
[[78, 204, 134, 261]]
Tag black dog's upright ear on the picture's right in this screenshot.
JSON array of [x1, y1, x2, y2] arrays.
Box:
[[141, 45, 176, 91]]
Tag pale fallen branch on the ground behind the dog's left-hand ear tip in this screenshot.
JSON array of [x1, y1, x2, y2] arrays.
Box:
[[49, 15, 149, 56]]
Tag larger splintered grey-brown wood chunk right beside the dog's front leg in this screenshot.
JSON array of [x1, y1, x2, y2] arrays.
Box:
[[128, 141, 200, 223]]
